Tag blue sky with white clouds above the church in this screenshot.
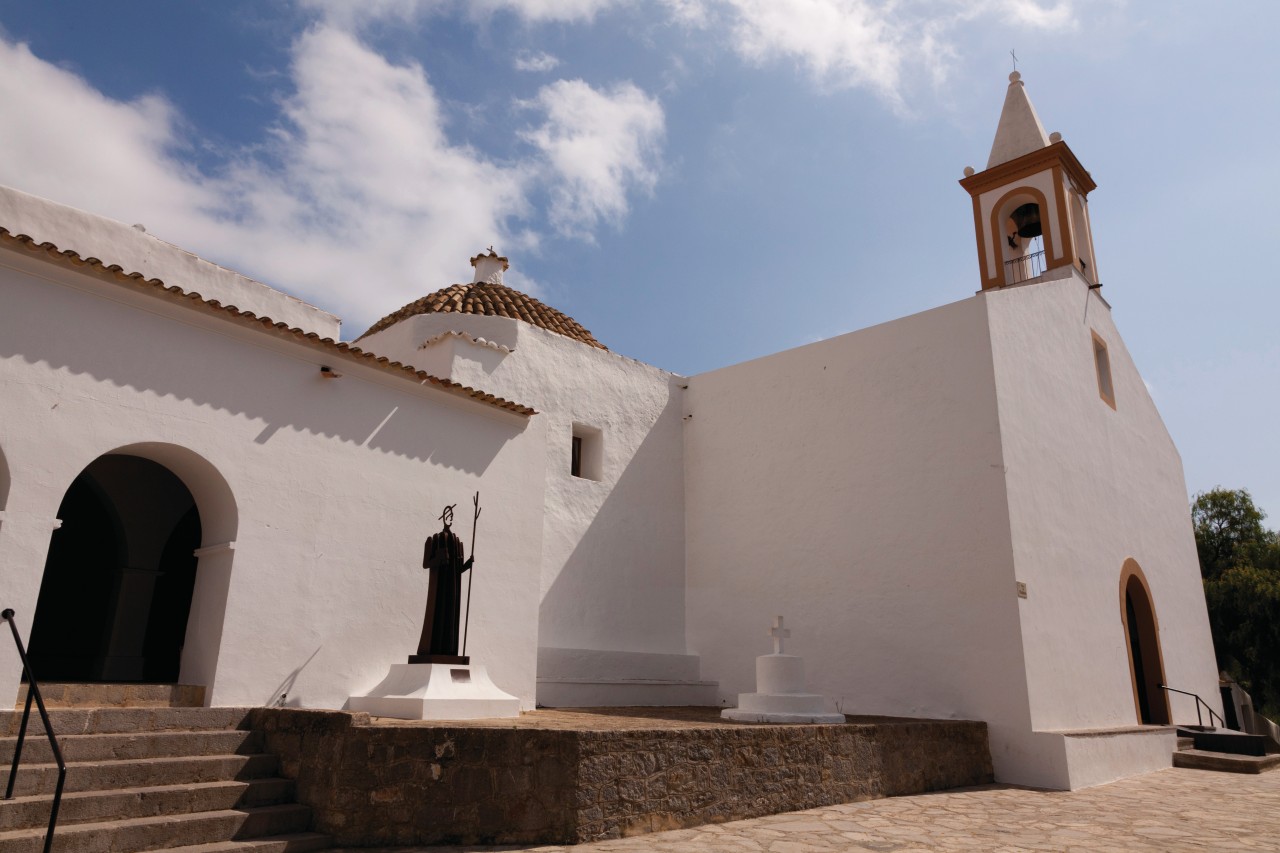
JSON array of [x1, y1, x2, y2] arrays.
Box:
[[0, 0, 1280, 517]]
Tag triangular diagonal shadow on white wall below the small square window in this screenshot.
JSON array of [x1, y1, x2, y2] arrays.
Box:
[[538, 381, 685, 653]]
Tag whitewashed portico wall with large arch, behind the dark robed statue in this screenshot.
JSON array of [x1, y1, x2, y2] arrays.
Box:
[[0, 250, 545, 707]]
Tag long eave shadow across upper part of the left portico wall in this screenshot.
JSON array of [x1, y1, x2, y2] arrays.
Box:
[[0, 287, 527, 471]]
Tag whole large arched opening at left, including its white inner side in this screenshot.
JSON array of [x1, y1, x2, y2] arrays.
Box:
[[29, 444, 237, 685]]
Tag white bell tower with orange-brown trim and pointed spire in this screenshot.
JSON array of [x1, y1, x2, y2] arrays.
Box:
[[960, 70, 1098, 291]]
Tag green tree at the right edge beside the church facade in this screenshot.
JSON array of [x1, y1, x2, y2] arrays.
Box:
[[1192, 488, 1280, 719]]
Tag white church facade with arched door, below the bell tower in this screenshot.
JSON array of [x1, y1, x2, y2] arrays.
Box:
[[988, 270, 1221, 730]]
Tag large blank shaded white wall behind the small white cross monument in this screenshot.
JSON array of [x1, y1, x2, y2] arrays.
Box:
[[685, 297, 1062, 780]]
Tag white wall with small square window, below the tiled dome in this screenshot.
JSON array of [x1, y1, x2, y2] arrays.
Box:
[[360, 314, 685, 655]]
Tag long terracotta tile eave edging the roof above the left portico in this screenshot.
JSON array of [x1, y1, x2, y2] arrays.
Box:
[[0, 225, 538, 416]]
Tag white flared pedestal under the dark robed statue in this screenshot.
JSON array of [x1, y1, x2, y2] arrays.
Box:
[[347, 663, 520, 720]]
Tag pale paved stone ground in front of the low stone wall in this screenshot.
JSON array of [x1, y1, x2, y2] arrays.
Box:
[[335, 768, 1280, 853]]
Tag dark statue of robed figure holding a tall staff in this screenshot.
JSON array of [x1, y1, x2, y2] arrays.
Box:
[[408, 493, 480, 663]]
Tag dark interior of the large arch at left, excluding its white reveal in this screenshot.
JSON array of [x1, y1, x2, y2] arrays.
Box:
[[29, 452, 201, 681]]
